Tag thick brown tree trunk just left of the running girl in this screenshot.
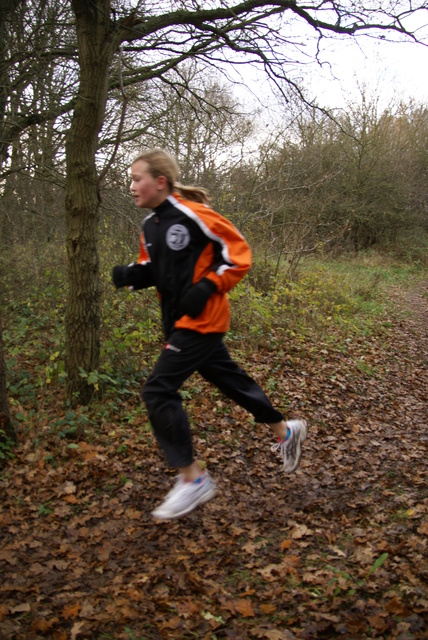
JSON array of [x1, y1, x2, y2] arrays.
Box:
[[65, 0, 116, 405]]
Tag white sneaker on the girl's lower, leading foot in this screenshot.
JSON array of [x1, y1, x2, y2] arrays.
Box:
[[152, 471, 217, 520]]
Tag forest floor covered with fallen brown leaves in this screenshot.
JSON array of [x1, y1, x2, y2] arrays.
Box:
[[0, 283, 428, 640]]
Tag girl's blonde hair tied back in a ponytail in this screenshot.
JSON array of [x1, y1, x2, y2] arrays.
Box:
[[132, 148, 209, 204]]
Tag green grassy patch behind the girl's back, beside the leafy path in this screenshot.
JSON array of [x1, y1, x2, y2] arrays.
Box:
[[230, 252, 427, 347]]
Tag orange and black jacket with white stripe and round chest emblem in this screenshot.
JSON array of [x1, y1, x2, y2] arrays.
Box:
[[129, 193, 251, 337]]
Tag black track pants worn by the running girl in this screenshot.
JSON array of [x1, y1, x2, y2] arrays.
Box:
[[141, 329, 283, 467]]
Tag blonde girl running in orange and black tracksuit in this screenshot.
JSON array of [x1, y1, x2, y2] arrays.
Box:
[[113, 149, 307, 520]]
